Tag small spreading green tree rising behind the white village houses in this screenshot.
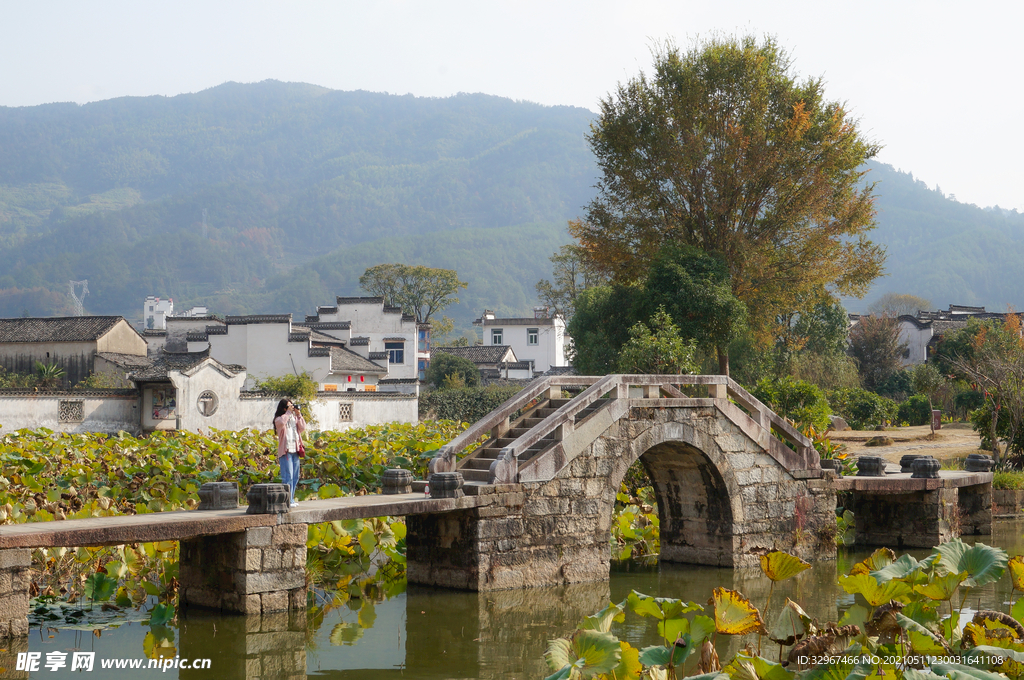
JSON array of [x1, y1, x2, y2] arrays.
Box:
[[359, 264, 467, 323]]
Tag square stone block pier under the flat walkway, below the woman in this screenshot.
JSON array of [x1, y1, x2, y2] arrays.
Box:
[[178, 524, 306, 613]]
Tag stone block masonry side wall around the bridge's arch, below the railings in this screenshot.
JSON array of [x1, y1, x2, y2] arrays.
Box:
[[406, 406, 836, 591]]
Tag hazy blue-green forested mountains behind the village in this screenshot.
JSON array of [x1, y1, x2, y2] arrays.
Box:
[[0, 81, 1024, 327]]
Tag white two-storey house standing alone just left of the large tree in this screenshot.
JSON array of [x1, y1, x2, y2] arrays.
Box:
[[473, 307, 568, 373]]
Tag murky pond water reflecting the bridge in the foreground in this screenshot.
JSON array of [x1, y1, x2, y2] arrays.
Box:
[[8, 522, 1024, 680]]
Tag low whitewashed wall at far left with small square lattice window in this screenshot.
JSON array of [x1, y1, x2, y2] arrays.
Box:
[[0, 390, 141, 434]]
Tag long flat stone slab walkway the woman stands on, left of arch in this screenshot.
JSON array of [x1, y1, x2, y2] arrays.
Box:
[[0, 490, 502, 549]]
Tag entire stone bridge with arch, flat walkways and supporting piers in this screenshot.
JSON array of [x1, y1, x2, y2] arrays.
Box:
[[0, 375, 992, 639]]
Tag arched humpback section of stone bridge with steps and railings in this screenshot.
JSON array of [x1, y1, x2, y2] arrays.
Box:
[[407, 375, 836, 590]]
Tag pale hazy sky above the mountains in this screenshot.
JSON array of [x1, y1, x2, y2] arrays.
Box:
[[0, 0, 1024, 211]]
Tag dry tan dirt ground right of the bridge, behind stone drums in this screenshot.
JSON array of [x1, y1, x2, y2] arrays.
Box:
[[828, 423, 985, 463]]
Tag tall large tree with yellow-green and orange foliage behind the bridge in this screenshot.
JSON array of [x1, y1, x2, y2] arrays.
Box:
[[570, 37, 884, 374]]
